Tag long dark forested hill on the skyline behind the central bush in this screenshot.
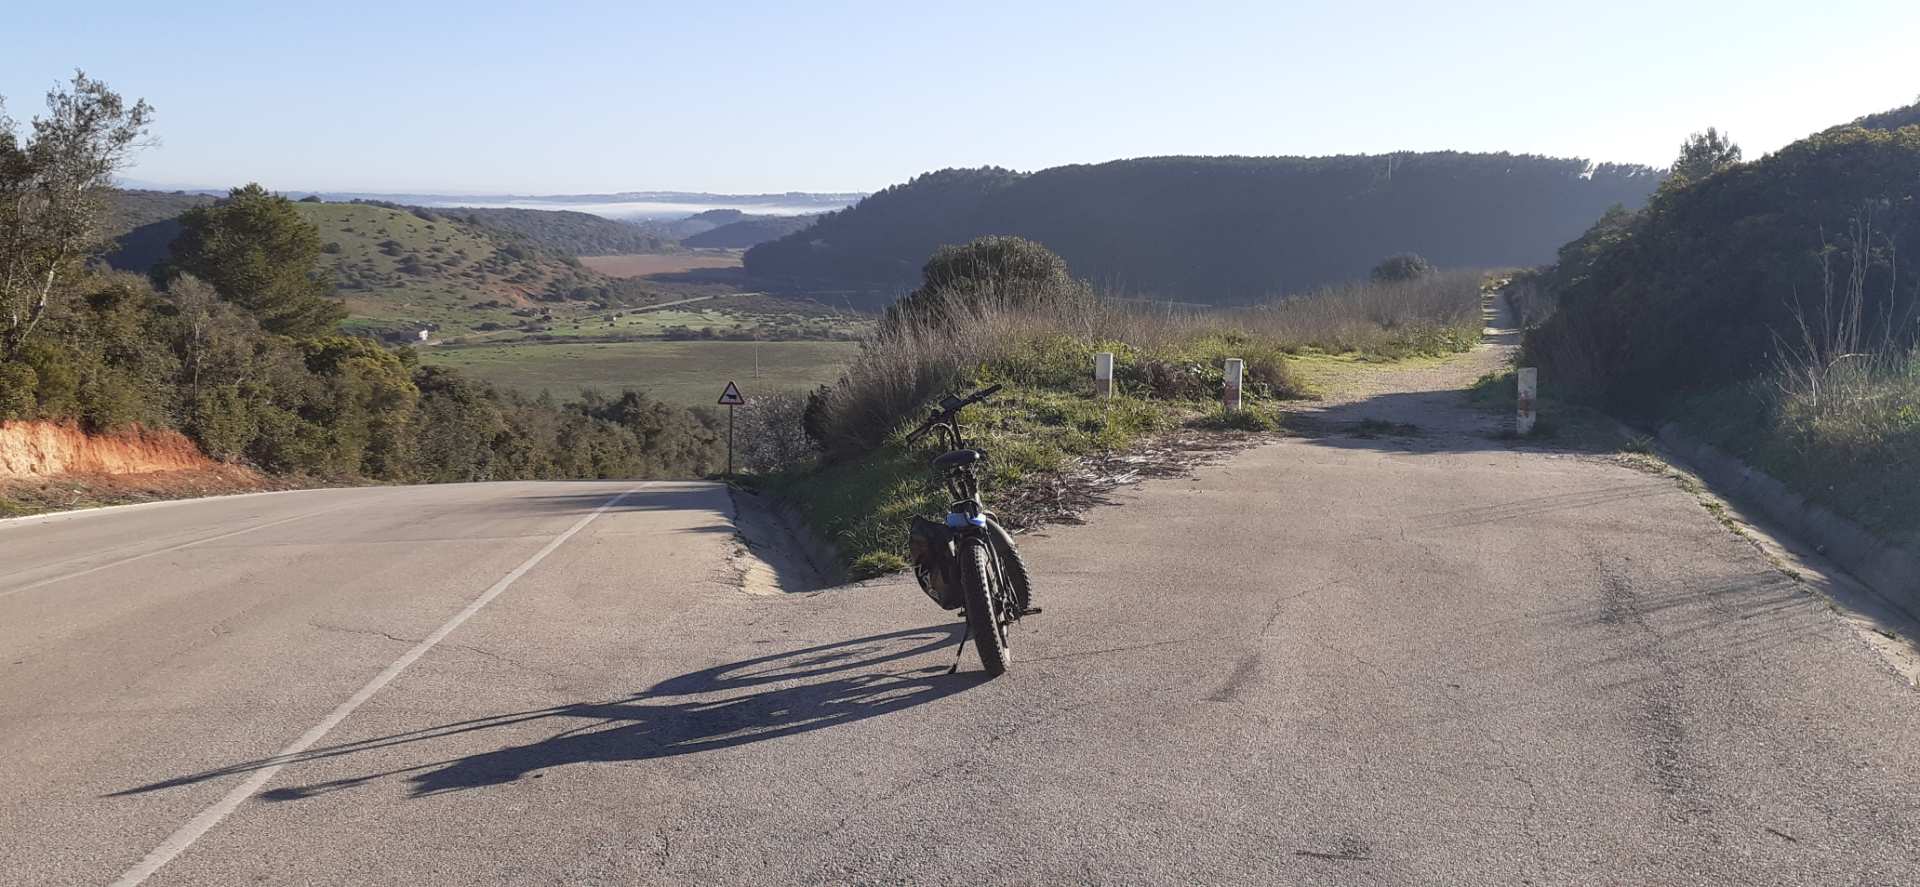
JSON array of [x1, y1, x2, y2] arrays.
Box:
[[747, 152, 1661, 303]]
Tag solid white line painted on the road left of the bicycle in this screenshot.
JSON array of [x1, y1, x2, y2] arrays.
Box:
[[113, 488, 639, 887]]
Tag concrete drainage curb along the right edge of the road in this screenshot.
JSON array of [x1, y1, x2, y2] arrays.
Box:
[[1659, 422, 1920, 618]]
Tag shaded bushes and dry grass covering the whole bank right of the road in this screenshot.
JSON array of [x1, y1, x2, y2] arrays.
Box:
[[1509, 106, 1920, 539]]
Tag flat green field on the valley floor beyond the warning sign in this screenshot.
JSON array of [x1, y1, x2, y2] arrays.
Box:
[[435, 342, 860, 407]]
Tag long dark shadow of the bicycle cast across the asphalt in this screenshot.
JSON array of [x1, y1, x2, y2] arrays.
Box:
[[109, 624, 987, 801]]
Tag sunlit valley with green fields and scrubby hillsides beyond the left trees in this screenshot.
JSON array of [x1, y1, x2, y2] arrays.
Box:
[[95, 192, 872, 407]]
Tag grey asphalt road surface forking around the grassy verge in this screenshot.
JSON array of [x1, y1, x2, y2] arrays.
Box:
[[0, 407, 1920, 887]]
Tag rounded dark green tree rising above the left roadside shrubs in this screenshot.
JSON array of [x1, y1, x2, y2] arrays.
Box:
[[163, 184, 346, 338]]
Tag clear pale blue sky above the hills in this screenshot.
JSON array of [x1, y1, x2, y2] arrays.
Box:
[[0, 0, 1920, 194]]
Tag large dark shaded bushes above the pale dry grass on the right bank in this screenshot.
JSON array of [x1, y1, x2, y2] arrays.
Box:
[[1524, 127, 1920, 417]]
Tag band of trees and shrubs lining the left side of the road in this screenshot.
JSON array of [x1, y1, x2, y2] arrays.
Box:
[[0, 75, 724, 495]]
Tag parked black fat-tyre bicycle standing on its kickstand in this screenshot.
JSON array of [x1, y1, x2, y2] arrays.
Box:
[[906, 386, 1041, 676]]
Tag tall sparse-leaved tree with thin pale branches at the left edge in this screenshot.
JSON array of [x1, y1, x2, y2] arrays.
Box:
[[0, 71, 154, 359]]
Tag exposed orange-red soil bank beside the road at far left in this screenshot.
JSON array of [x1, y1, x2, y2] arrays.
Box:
[[0, 422, 221, 480]]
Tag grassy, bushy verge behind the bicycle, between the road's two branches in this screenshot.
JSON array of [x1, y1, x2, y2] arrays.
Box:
[[753, 236, 1480, 576]]
